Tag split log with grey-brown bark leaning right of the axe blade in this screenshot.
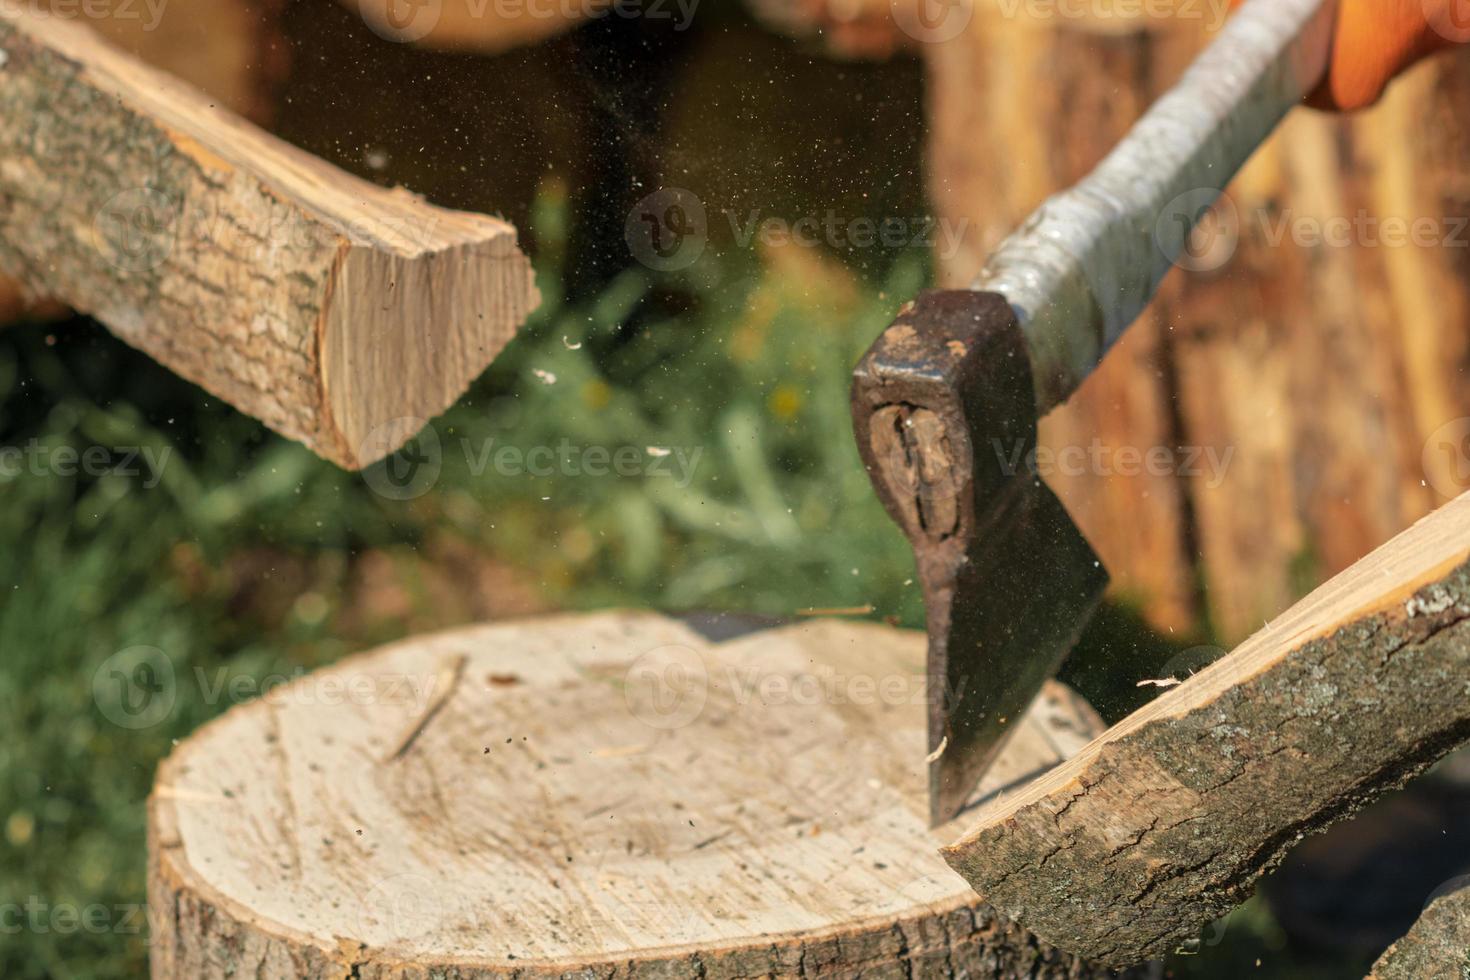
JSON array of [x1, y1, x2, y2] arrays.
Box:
[[945, 495, 1470, 965]]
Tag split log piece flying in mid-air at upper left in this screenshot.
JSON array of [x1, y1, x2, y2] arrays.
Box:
[[0, 0, 538, 469]]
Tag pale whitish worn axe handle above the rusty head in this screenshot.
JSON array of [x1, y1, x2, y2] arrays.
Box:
[[973, 0, 1336, 414]]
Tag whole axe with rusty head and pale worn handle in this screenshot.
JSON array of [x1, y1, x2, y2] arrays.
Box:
[[853, 0, 1336, 824]]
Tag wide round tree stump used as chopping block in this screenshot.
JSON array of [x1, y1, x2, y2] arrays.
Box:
[[148, 613, 1103, 980]]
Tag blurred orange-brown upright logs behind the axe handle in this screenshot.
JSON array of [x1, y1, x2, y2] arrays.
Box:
[[925, 11, 1470, 642]]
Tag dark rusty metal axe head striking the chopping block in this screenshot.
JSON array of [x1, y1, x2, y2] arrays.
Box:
[[853, 289, 1107, 824]]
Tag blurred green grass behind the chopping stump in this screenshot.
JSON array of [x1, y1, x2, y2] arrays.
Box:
[[0, 188, 1341, 980]]
